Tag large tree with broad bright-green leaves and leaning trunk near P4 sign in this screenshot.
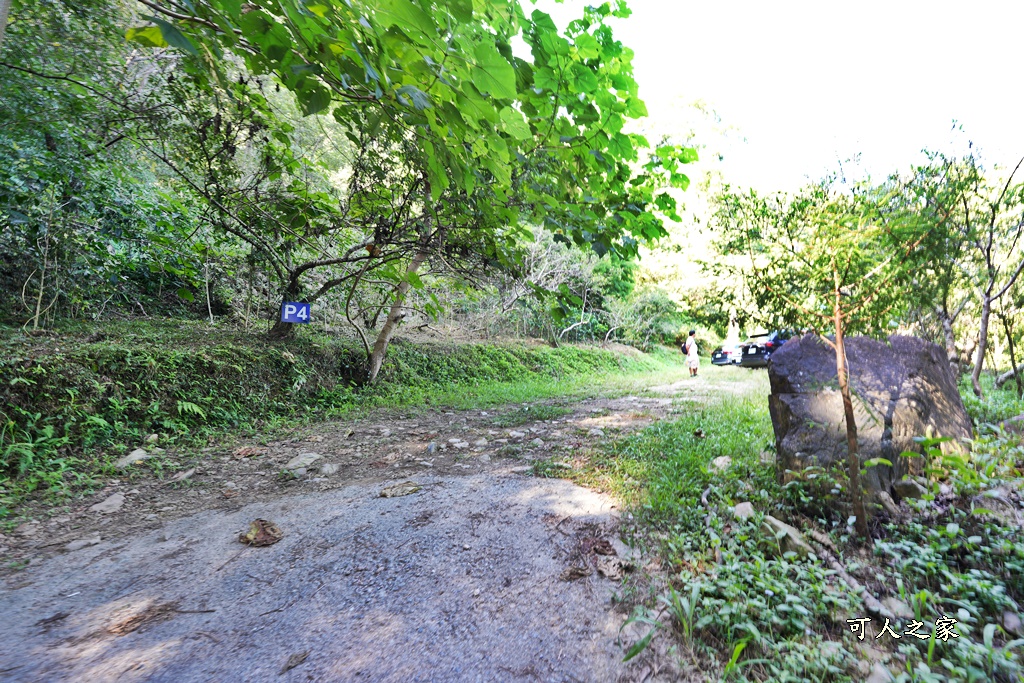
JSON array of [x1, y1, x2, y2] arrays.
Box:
[[128, 0, 695, 381]]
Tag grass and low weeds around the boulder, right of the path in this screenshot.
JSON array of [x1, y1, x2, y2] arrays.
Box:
[[547, 369, 1024, 683]]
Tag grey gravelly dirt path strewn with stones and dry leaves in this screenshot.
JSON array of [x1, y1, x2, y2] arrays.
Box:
[[0, 370, 770, 681]]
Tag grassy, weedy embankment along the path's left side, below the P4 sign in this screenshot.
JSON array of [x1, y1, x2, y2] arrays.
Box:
[[0, 321, 683, 517]]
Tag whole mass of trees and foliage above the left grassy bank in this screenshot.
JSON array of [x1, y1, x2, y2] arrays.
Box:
[[0, 0, 695, 381]]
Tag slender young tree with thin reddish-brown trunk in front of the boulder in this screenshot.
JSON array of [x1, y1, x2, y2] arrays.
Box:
[[716, 180, 936, 542]]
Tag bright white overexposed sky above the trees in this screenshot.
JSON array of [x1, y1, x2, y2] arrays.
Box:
[[525, 0, 1024, 190]]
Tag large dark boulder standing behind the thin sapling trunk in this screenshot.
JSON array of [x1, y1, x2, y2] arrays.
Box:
[[768, 335, 972, 500]]
